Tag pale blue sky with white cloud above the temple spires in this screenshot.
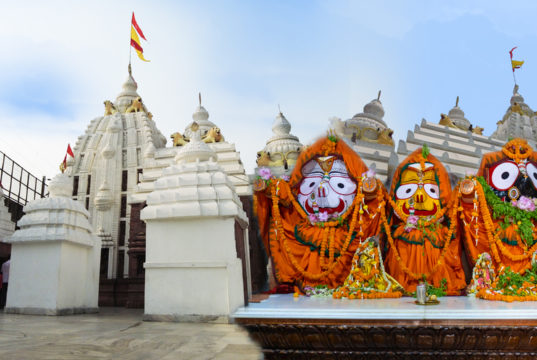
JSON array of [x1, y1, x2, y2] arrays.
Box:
[[0, 1, 537, 177]]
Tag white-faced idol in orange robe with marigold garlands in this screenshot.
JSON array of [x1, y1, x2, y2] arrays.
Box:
[[254, 136, 385, 289]]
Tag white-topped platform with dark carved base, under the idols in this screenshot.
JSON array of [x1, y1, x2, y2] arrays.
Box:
[[234, 294, 537, 360]]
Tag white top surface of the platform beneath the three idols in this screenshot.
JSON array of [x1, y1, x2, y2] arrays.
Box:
[[233, 294, 537, 320]]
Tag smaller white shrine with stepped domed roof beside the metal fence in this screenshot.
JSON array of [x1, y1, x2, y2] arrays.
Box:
[[5, 174, 101, 315]]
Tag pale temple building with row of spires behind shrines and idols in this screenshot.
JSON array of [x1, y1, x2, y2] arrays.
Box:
[[38, 67, 537, 307]]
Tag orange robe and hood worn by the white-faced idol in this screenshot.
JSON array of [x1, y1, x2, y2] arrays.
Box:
[[255, 138, 385, 288]]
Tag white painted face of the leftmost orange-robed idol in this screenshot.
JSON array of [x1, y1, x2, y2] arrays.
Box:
[[298, 159, 356, 221]]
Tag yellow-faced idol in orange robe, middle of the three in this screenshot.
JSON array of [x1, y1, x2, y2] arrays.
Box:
[[382, 146, 466, 295]]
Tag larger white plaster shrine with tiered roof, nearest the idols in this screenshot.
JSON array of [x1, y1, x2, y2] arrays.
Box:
[[141, 123, 250, 321]]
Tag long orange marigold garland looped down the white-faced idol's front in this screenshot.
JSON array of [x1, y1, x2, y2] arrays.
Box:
[[271, 180, 383, 281]]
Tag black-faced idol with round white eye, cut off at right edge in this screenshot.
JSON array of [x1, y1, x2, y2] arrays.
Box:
[[459, 139, 537, 274]]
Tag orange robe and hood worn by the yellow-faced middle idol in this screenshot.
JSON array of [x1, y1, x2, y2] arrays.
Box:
[[385, 149, 466, 295]]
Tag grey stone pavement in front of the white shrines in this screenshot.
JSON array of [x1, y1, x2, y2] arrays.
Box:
[[0, 308, 263, 360]]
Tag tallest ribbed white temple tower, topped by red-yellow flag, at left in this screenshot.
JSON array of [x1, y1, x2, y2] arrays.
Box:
[[68, 66, 166, 305]]
